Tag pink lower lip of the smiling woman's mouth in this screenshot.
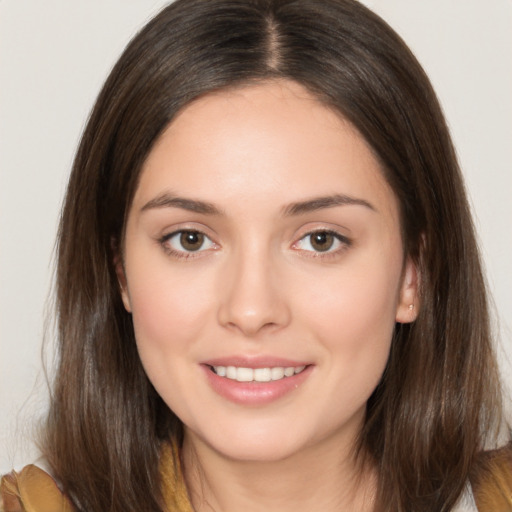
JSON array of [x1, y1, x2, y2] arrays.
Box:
[[202, 365, 312, 405]]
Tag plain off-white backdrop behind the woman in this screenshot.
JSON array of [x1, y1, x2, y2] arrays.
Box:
[[0, 0, 512, 473]]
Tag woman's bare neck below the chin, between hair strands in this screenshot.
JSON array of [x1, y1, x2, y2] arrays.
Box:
[[182, 434, 376, 512]]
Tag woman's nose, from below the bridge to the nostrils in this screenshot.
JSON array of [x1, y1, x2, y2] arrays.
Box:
[[218, 243, 291, 337]]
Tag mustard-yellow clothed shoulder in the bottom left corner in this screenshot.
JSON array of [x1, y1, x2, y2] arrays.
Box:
[[0, 465, 73, 512]]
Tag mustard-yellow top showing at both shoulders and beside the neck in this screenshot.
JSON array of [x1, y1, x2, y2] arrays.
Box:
[[0, 444, 512, 512]]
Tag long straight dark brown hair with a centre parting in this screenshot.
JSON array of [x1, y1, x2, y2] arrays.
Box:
[[46, 0, 508, 512]]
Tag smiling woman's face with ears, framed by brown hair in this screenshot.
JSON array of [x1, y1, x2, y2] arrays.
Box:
[[118, 81, 416, 460]]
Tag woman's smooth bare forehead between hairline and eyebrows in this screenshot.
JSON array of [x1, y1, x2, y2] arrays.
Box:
[[134, 80, 396, 222]]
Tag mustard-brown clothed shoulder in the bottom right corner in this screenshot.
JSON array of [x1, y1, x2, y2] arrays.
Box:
[[471, 443, 512, 512]]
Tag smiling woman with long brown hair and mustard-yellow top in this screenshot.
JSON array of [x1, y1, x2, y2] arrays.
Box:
[[2, 0, 512, 511]]
